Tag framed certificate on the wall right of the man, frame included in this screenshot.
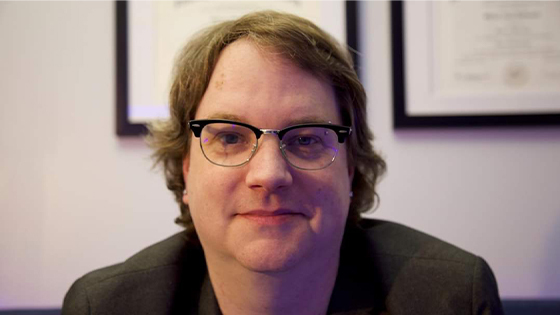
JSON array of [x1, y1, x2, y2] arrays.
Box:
[[391, 1, 560, 128]]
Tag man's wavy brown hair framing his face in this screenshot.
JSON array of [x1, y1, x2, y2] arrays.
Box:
[[148, 11, 386, 235]]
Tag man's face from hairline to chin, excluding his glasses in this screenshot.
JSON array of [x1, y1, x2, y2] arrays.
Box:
[[183, 40, 352, 272]]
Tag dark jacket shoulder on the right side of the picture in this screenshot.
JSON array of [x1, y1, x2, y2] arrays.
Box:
[[345, 220, 502, 314]]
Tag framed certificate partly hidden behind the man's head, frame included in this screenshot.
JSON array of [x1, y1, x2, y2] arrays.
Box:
[[116, 0, 357, 136]]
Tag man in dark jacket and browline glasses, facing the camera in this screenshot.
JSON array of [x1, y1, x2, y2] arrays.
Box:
[[63, 12, 502, 314]]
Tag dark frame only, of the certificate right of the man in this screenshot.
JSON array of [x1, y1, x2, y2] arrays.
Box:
[[391, 1, 560, 128]]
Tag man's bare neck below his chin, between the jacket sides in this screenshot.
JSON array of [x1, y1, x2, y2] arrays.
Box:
[[206, 252, 339, 315]]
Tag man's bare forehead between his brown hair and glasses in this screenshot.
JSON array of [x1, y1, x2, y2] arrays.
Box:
[[196, 39, 341, 128]]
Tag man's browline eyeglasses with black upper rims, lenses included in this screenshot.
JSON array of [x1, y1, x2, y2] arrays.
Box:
[[189, 119, 352, 170]]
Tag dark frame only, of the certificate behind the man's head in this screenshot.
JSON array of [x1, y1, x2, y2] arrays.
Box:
[[115, 1, 358, 136]]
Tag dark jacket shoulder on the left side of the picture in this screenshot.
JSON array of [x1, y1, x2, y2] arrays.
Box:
[[62, 232, 205, 314]]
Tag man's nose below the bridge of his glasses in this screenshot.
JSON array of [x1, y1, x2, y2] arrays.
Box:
[[245, 135, 293, 193]]
